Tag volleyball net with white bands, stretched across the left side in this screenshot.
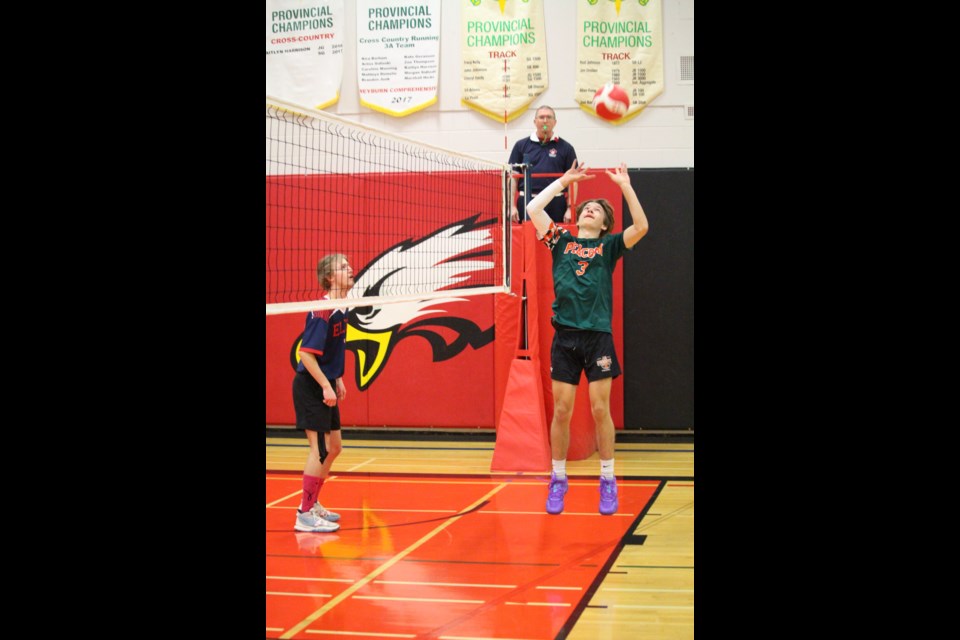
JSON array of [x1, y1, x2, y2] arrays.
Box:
[[266, 96, 511, 315]]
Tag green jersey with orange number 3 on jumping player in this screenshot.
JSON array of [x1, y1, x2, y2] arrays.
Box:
[[543, 224, 626, 333]]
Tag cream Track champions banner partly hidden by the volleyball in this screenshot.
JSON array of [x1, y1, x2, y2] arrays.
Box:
[[574, 0, 663, 124]]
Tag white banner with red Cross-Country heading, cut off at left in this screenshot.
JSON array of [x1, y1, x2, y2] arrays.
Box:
[[267, 0, 346, 109]]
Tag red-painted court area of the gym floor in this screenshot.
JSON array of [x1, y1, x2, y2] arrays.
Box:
[[266, 472, 660, 640]]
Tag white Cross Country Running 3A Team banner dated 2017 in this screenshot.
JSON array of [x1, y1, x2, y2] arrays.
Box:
[[357, 0, 440, 116]]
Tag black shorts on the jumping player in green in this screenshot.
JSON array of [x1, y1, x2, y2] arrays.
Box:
[[550, 325, 620, 384]]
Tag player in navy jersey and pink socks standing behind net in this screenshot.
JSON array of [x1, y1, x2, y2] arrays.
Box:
[[293, 253, 354, 532]]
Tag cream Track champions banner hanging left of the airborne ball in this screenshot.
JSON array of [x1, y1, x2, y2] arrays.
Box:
[[460, 0, 547, 123]]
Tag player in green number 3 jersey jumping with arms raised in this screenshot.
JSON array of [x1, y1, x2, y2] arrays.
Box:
[[527, 162, 648, 515]]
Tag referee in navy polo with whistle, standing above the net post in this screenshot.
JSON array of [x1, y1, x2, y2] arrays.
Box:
[[508, 105, 577, 222]]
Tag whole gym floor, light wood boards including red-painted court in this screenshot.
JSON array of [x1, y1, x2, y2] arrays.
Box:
[[265, 431, 694, 640]]
